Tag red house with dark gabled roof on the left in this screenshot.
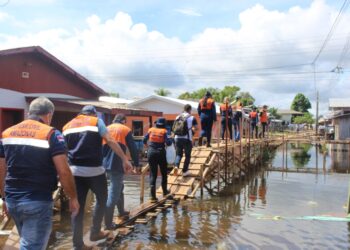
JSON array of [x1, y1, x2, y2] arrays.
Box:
[[0, 46, 162, 135]]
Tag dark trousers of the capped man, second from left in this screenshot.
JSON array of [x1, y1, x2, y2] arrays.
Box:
[[72, 174, 107, 249]]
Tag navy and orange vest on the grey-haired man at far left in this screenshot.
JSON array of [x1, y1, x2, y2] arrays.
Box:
[[2, 120, 57, 200]]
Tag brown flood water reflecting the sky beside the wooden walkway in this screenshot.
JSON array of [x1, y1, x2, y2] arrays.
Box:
[[50, 144, 350, 249]]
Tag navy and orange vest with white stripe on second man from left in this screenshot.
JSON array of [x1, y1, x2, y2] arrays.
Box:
[[63, 115, 102, 167]]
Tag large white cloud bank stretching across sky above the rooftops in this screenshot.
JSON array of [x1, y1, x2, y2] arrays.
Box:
[[0, 0, 350, 114]]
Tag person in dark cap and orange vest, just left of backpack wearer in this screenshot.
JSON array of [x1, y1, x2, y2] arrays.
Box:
[[143, 117, 172, 202]]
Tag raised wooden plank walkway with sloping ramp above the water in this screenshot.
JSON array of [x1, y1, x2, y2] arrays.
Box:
[[0, 136, 290, 249]]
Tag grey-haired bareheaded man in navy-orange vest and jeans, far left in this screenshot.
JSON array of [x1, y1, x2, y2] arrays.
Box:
[[0, 97, 79, 249]]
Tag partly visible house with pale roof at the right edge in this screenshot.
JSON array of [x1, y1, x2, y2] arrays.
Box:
[[328, 98, 350, 140]]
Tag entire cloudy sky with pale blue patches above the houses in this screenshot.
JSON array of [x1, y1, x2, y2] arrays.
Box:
[[0, 0, 350, 113]]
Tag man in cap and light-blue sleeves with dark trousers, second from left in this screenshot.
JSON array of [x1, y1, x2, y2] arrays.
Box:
[[63, 105, 132, 249]]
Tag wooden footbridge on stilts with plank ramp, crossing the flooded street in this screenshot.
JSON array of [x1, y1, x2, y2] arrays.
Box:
[[2, 128, 344, 249]]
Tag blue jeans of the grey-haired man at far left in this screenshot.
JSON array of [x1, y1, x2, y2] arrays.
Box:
[[6, 200, 53, 250]]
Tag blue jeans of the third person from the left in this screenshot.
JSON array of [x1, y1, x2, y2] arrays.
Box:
[[105, 172, 125, 229]]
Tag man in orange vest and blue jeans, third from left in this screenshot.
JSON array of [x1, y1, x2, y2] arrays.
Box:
[[103, 114, 140, 229]]
